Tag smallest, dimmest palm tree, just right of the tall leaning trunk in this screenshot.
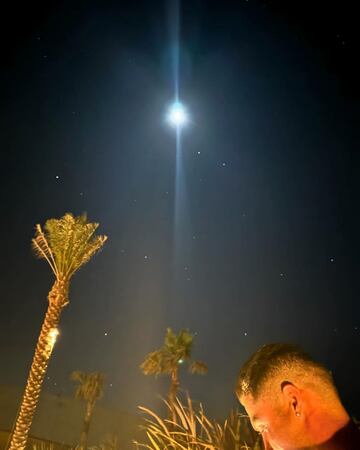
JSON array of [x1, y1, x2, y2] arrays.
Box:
[[71, 370, 105, 449]]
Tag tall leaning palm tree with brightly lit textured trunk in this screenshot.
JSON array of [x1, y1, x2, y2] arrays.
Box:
[[9, 213, 107, 450]]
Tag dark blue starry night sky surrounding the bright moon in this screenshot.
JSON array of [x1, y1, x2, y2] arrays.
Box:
[[0, 0, 360, 422]]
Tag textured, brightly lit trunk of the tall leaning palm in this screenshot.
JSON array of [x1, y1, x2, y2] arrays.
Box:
[[9, 280, 69, 450]]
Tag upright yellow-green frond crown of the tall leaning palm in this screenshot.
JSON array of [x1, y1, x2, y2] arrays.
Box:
[[32, 213, 107, 280]]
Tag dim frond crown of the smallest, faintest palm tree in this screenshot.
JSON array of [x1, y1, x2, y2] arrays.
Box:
[[70, 370, 105, 402]]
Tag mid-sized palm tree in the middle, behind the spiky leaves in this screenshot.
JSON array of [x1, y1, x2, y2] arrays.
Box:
[[140, 328, 208, 417]]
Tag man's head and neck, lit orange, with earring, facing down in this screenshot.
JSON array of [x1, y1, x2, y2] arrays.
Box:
[[236, 344, 347, 450]]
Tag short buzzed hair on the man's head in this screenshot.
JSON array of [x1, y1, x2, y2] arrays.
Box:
[[236, 343, 336, 399]]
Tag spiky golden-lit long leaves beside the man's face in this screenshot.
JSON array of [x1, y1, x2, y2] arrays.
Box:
[[134, 397, 260, 450]]
